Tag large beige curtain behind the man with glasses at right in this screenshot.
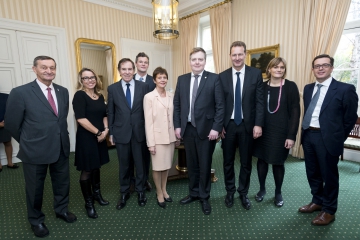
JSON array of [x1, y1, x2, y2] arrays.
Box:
[[292, 0, 351, 158]]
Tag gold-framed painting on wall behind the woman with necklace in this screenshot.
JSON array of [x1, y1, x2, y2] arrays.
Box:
[[246, 44, 280, 79]]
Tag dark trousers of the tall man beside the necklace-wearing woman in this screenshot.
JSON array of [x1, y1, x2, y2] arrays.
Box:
[[222, 120, 254, 195]]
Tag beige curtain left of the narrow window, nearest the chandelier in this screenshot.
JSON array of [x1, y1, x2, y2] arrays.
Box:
[[180, 14, 200, 74]]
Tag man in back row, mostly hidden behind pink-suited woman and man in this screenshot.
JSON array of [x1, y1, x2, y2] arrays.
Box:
[[130, 52, 155, 192]]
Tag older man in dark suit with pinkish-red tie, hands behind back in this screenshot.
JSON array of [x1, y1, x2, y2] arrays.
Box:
[[5, 56, 76, 237]]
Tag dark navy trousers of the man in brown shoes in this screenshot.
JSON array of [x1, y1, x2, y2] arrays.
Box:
[[302, 130, 339, 214]]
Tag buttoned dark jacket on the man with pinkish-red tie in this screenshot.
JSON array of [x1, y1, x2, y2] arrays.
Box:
[[5, 81, 70, 164]]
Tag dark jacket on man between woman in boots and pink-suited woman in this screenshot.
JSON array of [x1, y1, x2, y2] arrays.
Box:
[[108, 80, 149, 144]]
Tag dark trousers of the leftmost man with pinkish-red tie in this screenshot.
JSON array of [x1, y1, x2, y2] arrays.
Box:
[[23, 150, 70, 225]]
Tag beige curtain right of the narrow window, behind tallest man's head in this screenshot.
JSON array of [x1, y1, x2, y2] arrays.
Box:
[[209, 2, 232, 73]]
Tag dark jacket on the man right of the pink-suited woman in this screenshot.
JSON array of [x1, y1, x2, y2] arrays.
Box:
[[174, 71, 224, 139]]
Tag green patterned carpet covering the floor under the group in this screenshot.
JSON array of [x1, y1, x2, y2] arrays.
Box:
[[0, 143, 360, 240]]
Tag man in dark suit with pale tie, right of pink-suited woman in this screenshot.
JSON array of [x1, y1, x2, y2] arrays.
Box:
[[174, 48, 224, 215]]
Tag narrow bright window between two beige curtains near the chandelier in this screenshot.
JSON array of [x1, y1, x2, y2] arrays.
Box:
[[198, 14, 215, 72]]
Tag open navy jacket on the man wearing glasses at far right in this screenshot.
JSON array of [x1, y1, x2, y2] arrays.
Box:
[[301, 78, 358, 156]]
